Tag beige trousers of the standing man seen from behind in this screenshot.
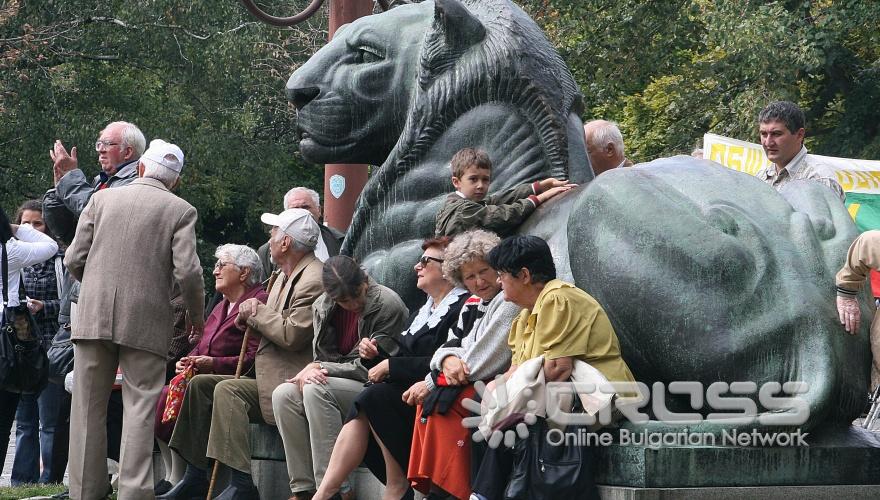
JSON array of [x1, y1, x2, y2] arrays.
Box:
[[69, 340, 165, 500]]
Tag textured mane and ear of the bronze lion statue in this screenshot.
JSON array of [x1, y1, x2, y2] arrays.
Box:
[[343, 0, 592, 255]]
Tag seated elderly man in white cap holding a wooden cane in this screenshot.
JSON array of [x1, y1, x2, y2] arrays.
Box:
[[157, 208, 323, 500]]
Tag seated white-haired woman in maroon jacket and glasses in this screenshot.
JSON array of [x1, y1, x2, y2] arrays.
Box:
[[156, 244, 268, 494]]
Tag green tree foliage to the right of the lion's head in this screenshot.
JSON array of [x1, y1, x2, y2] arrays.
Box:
[[524, 0, 880, 161]]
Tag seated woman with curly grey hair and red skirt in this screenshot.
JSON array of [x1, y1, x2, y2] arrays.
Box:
[[407, 230, 520, 499]]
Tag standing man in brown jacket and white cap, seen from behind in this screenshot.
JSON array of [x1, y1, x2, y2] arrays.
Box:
[[64, 139, 205, 500]]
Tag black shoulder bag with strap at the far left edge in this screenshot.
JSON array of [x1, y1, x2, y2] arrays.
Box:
[[0, 243, 49, 393]]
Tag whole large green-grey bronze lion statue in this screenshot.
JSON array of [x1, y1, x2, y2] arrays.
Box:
[[287, 0, 870, 430]]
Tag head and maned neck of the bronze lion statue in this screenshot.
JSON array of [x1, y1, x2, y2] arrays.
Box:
[[287, 0, 593, 287]]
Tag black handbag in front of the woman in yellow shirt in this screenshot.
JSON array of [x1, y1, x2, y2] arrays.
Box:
[[504, 397, 599, 500]]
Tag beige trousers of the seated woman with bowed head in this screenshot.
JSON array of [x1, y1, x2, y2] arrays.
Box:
[[272, 377, 364, 493]]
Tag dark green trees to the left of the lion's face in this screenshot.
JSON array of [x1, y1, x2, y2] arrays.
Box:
[[0, 0, 326, 260]]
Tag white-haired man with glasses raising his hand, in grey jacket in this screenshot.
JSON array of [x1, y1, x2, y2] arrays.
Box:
[[43, 122, 147, 243]]
